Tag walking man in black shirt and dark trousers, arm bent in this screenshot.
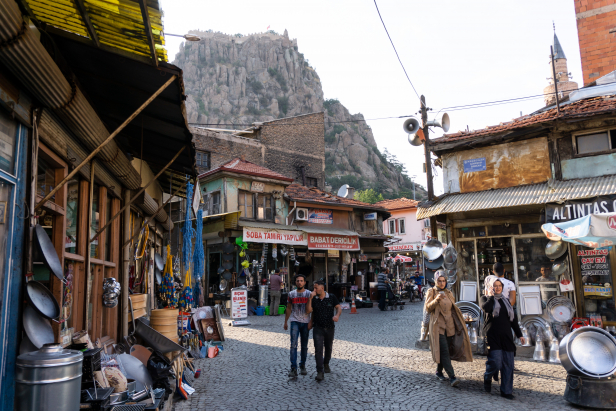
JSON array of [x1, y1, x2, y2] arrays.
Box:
[[306, 280, 342, 381]]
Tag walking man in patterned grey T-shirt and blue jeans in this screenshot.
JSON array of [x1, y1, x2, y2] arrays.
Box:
[[284, 274, 310, 378]]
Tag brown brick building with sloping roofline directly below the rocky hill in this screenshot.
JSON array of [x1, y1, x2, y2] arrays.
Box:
[[191, 112, 325, 189]]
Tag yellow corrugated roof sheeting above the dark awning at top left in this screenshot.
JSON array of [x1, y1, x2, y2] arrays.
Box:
[[26, 0, 167, 62]]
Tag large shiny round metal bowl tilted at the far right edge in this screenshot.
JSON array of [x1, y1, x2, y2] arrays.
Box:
[[558, 327, 616, 378]]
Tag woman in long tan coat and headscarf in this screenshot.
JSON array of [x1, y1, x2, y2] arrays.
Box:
[[425, 270, 473, 387]]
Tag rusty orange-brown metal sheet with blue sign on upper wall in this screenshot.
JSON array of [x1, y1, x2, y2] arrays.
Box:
[[455, 137, 551, 193]]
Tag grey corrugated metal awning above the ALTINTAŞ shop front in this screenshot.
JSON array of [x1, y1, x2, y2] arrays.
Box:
[[417, 175, 616, 220]]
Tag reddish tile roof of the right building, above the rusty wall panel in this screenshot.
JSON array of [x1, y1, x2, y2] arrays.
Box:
[[431, 95, 616, 150]]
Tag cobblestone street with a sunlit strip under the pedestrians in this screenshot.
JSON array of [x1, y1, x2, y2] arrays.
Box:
[[175, 302, 580, 411]]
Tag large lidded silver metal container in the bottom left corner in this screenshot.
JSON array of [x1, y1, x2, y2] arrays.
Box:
[[15, 344, 83, 411]]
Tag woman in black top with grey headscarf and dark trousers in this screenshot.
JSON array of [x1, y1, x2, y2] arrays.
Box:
[[480, 277, 524, 400]]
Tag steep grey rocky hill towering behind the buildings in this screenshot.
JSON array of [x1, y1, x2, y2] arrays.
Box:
[[174, 30, 426, 199]]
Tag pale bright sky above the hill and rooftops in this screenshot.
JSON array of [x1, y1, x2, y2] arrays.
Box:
[[160, 0, 583, 194]]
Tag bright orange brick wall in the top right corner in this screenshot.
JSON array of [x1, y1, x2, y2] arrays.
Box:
[[574, 0, 616, 85]]
